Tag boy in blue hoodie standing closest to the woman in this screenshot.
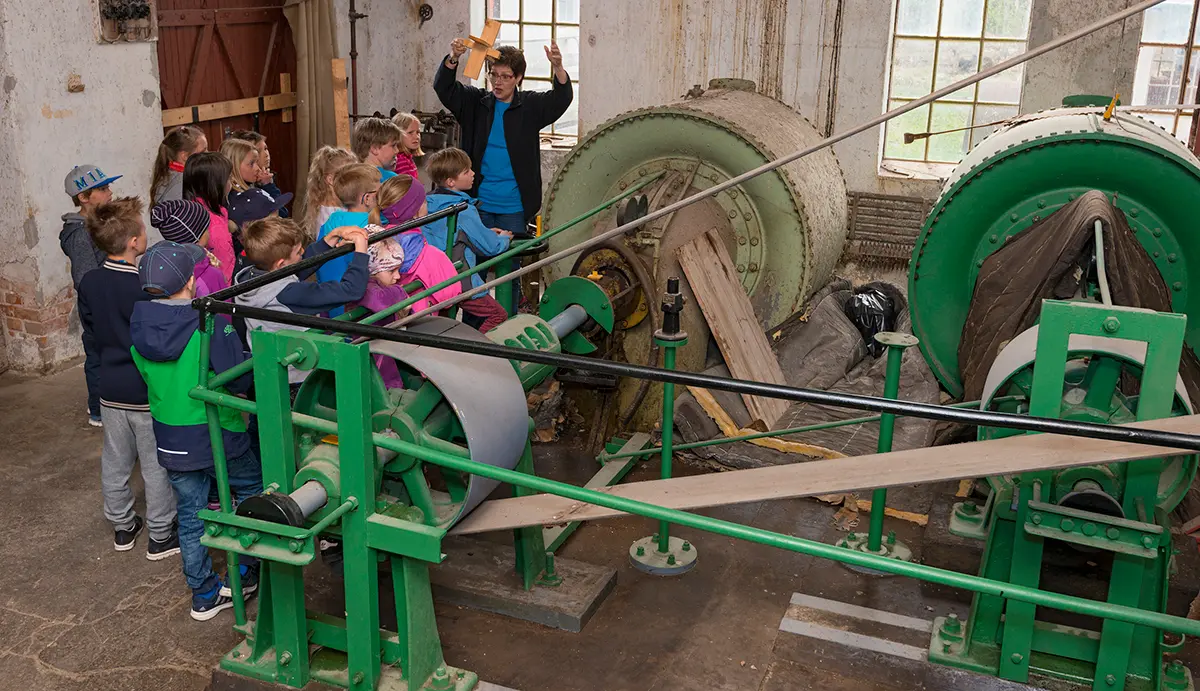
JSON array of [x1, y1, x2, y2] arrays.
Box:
[[422, 149, 512, 334]]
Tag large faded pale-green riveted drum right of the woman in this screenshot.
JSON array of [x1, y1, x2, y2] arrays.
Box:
[[542, 79, 847, 426]]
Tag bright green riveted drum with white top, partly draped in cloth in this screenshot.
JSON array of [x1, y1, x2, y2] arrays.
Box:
[[908, 108, 1200, 395]]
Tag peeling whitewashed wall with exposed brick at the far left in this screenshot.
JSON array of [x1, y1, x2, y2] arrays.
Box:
[[0, 0, 162, 371]]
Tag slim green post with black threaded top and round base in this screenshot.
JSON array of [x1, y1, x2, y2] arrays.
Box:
[[629, 278, 696, 576]]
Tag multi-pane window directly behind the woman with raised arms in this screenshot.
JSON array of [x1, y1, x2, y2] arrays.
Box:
[[486, 0, 580, 137]]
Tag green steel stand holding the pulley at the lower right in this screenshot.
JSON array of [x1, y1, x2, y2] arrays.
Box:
[[929, 300, 1193, 691]]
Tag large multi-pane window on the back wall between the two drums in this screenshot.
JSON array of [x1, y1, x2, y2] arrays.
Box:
[[883, 0, 1032, 163]]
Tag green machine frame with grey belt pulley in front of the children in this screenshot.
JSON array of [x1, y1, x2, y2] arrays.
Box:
[[200, 277, 613, 691]]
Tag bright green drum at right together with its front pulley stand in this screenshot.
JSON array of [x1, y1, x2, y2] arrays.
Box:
[[908, 107, 1200, 691]]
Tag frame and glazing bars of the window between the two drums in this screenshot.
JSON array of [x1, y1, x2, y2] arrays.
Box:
[[880, 0, 1032, 170]]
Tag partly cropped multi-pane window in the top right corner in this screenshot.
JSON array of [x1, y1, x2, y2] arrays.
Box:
[[1130, 0, 1200, 142]]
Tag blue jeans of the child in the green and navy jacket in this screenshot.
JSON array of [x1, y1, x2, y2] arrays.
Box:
[[167, 451, 263, 593]]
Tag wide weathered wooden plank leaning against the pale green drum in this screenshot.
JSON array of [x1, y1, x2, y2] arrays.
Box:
[[678, 230, 788, 429]]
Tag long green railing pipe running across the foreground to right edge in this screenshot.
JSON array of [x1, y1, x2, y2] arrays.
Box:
[[182, 387, 1200, 636]]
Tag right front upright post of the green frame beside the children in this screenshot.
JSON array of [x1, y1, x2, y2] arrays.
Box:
[[335, 343, 380, 691]]
